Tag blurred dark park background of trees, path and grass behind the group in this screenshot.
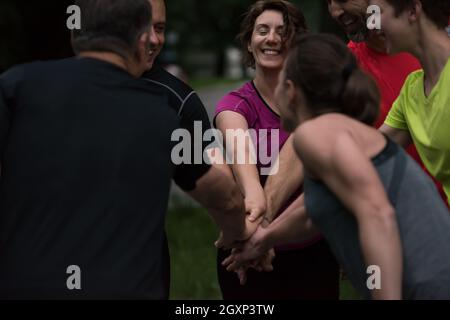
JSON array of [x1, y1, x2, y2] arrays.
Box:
[[0, 0, 358, 299]]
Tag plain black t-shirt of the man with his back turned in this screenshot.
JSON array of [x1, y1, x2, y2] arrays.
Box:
[[0, 58, 195, 299]]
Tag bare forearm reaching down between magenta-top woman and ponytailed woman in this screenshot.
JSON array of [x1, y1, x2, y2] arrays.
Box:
[[264, 135, 303, 221]]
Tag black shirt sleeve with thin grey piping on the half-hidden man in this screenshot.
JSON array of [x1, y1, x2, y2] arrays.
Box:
[[143, 66, 212, 191]]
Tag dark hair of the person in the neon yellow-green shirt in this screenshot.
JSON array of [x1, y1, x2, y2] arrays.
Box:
[[387, 0, 450, 29]]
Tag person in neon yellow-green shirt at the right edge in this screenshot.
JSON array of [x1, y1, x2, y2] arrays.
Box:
[[371, 0, 450, 205]]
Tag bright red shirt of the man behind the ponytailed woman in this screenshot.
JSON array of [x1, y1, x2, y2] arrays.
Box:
[[348, 41, 448, 205]]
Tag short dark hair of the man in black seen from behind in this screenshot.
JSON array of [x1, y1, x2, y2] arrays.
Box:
[[72, 0, 152, 57]]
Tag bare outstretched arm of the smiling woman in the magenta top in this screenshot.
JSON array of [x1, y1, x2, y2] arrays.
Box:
[[216, 111, 266, 217]]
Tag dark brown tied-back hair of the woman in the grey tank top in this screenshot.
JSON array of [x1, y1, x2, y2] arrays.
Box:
[[285, 34, 380, 125]]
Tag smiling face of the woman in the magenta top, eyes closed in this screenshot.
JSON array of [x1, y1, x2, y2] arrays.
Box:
[[248, 10, 287, 70]]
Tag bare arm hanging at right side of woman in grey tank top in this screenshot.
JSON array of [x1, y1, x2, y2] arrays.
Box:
[[295, 128, 402, 299]]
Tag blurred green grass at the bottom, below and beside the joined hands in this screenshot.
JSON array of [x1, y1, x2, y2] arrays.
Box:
[[166, 205, 359, 300]]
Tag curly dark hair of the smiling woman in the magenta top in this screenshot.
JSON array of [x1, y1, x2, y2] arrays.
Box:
[[237, 0, 308, 67]]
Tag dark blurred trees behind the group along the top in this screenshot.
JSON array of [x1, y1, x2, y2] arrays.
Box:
[[0, 0, 344, 79]]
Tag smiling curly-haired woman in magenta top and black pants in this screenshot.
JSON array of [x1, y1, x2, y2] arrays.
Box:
[[214, 0, 339, 299]]
